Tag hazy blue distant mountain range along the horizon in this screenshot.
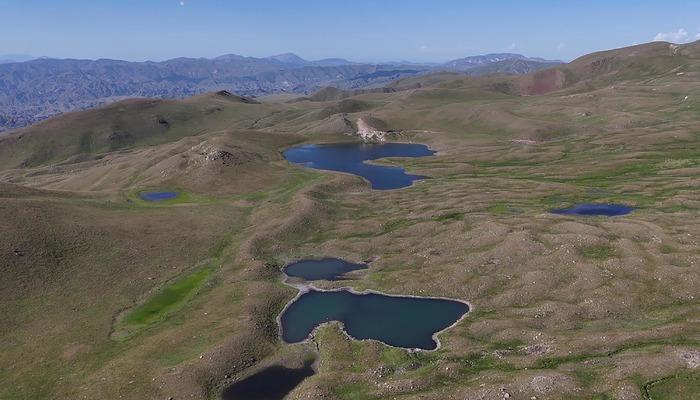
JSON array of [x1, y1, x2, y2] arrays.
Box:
[[0, 53, 561, 131]]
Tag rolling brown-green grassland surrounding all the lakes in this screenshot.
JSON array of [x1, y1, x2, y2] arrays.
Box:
[[0, 38, 700, 400]]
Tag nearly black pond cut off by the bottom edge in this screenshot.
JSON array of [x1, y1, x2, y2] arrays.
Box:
[[221, 362, 314, 400]]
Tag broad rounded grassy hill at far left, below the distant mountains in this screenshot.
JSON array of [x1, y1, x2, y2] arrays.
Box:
[[0, 92, 274, 169]]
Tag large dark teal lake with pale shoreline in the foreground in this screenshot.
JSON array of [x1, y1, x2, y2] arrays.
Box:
[[280, 289, 469, 350]]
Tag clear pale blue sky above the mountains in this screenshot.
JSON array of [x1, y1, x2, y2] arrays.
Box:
[[0, 0, 700, 61]]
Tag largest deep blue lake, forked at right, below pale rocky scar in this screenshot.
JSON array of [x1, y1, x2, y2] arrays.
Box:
[[284, 143, 435, 190]]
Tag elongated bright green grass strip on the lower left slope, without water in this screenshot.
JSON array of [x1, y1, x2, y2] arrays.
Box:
[[121, 267, 214, 336]]
